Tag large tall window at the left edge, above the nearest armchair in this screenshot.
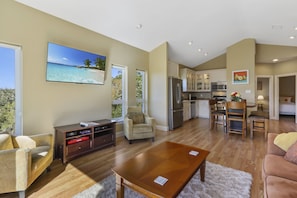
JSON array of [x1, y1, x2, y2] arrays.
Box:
[[0, 43, 23, 135]]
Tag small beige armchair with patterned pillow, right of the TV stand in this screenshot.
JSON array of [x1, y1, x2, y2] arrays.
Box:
[[124, 107, 155, 144]]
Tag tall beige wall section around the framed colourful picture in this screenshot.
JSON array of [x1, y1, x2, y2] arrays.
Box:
[[227, 39, 256, 103]]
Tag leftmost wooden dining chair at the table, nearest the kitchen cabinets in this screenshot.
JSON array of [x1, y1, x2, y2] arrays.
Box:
[[209, 99, 227, 132]]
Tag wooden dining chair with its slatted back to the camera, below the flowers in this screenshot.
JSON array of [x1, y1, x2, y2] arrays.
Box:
[[226, 100, 247, 139]]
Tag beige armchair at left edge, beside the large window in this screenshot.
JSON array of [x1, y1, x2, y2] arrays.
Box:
[[0, 134, 54, 197]]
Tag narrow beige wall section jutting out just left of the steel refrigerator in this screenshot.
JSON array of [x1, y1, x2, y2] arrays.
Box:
[[149, 42, 168, 131]]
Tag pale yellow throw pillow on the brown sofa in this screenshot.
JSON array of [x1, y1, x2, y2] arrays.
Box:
[[274, 132, 297, 152]]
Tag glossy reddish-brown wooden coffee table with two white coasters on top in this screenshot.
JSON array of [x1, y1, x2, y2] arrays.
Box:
[[112, 142, 209, 197]]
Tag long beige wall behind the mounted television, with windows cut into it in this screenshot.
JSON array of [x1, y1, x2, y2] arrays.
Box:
[[0, 0, 149, 134]]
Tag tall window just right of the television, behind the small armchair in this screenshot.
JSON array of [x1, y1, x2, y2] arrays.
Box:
[[111, 65, 126, 120]]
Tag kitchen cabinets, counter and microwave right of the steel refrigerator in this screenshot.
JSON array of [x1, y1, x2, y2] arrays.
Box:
[[180, 68, 227, 121]]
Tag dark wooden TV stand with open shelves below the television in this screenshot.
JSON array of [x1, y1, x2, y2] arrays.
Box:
[[55, 119, 116, 163]]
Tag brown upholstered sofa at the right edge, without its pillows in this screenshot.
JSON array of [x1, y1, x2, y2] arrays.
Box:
[[262, 132, 297, 198]]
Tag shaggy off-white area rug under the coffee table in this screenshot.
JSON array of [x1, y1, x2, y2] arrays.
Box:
[[74, 162, 252, 198]]
